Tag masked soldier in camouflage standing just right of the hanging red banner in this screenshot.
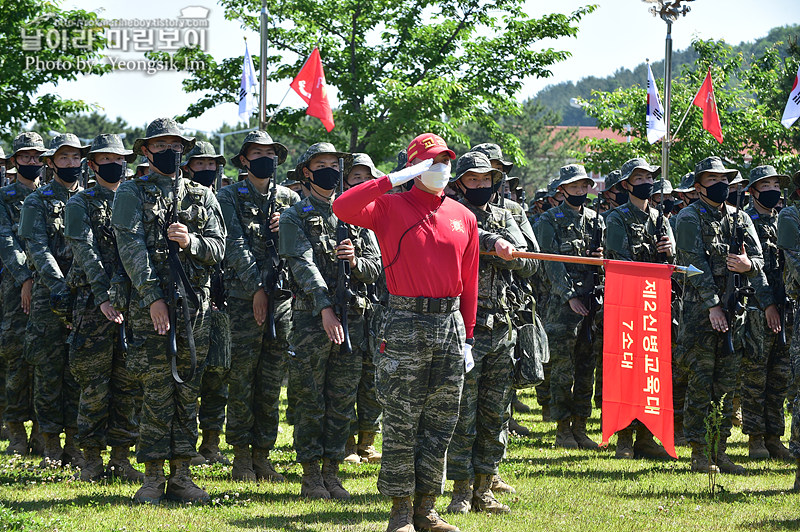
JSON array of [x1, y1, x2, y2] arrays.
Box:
[[676, 157, 764, 474]]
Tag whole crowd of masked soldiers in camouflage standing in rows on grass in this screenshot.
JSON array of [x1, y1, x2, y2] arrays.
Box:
[[0, 118, 800, 532]]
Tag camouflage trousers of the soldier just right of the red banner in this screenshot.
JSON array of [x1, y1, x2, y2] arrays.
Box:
[[677, 301, 741, 444]]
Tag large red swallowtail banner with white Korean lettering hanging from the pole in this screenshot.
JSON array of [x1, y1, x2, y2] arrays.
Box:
[[603, 260, 677, 458]]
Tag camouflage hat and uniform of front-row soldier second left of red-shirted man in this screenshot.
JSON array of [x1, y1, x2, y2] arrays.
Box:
[[217, 131, 300, 478]]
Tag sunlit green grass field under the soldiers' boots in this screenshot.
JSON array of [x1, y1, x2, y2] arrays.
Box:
[[0, 392, 800, 532]]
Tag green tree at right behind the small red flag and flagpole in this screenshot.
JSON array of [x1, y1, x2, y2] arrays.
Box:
[[576, 40, 800, 183]]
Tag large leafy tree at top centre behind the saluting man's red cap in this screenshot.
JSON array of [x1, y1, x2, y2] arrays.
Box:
[[145, 0, 594, 162]]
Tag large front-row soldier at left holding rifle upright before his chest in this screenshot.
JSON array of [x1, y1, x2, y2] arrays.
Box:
[[111, 118, 225, 503]]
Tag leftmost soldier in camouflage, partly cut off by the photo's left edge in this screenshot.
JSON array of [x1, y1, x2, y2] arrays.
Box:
[[0, 132, 47, 455]]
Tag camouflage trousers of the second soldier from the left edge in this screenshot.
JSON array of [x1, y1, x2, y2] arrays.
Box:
[[24, 281, 80, 434]]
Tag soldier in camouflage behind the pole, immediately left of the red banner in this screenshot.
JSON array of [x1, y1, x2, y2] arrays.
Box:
[[536, 164, 605, 449]]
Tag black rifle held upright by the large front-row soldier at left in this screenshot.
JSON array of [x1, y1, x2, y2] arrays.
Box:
[[162, 152, 200, 384]]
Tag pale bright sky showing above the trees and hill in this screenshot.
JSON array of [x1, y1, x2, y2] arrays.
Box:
[[45, 0, 800, 130]]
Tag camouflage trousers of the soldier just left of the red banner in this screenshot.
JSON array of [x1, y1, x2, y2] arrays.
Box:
[[545, 299, 597, 421]]
